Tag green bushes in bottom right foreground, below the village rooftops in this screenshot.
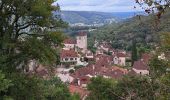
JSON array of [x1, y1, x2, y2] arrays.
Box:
[[87, 76, 162, 100]]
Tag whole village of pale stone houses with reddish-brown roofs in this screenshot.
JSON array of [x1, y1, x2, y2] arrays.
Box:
[[25, 32, 164, 100]]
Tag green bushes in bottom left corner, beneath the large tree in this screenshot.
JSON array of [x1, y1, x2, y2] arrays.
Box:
[[0, 73, 75, 100]]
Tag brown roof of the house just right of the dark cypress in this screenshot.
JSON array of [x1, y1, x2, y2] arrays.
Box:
[[133, 60, 148, 70]]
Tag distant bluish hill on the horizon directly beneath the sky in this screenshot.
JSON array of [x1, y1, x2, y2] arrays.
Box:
[[55, 11, 142, 26]]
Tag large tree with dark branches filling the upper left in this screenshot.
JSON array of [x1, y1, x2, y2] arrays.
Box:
[[0, 0, 66, 70]]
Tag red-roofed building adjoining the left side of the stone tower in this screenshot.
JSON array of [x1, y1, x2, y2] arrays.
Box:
[[63, 38, 77, 50]]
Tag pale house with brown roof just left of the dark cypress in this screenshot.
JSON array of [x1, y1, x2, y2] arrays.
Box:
[[113, 53, 126, 66]]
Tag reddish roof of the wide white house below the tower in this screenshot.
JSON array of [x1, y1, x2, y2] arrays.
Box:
[[60, 50, 78, 58]]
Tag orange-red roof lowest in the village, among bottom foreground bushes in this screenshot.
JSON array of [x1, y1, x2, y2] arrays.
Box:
[[69, 85, 89, 99]]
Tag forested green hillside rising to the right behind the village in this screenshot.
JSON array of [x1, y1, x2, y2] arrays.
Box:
[[89, 9, 170, 50]]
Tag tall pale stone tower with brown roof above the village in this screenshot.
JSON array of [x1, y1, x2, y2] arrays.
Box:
[[76, 32, 87, 51]]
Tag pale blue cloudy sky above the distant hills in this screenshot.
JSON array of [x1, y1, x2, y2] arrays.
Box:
[[54, 0, 141, 12]]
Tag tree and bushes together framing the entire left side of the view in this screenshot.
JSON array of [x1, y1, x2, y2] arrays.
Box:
[[0, 0, 76, 100]]
